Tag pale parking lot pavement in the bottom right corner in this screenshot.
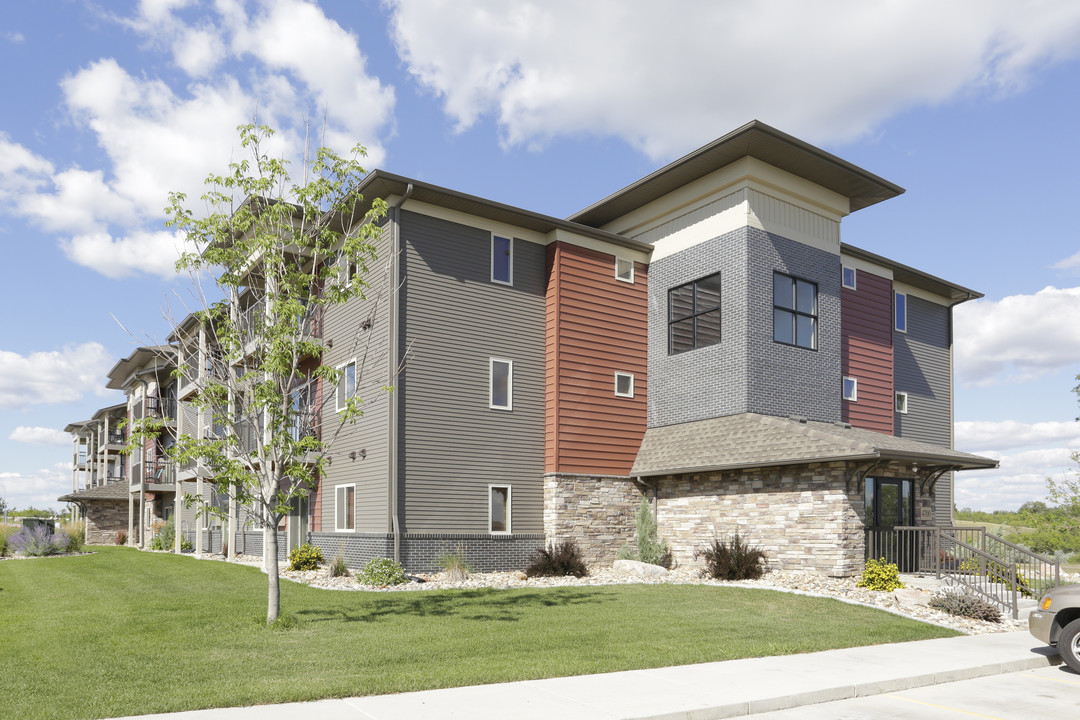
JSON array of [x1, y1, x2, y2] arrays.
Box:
[[747, 665, 1080, 720]]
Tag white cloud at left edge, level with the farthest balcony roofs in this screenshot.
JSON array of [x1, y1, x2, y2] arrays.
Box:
[[0, 342, 116, 409]]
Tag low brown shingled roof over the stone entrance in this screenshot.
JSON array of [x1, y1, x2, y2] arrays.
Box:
[[630, 412, 998, 477]]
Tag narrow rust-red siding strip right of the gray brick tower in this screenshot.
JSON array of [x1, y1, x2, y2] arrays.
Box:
[[840, 270, 893, 435]]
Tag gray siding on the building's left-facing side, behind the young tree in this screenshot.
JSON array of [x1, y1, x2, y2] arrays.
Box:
[[312, 223, 393, 532]]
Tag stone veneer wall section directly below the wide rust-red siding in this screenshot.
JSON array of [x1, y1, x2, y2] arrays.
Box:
[[543, 475, 642, 565]]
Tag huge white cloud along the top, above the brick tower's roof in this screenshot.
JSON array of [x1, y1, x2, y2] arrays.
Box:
[[387, 0, 1080, 159]]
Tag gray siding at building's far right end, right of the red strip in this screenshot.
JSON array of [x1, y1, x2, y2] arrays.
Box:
[[893, 295, 953, 525]]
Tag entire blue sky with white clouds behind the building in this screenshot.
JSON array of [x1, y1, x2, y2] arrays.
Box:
[[0, 0, 1080, 510]]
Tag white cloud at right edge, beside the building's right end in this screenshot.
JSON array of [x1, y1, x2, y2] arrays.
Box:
[[954, 287, 1080, 386]]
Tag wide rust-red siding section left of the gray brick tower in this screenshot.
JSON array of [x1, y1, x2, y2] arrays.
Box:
[[544, 242, 648, 475]]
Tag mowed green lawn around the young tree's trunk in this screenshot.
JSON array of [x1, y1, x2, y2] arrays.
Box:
[[0, 547, 956, 720]]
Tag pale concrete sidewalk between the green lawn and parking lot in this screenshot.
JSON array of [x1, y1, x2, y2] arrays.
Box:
[[116, 631, 1061, 720]]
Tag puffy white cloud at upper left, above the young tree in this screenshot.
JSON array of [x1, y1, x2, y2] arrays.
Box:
[[0, 0, 394, 279]]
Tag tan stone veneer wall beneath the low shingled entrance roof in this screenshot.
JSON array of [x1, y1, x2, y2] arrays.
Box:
[[657, 462, 933, 576]]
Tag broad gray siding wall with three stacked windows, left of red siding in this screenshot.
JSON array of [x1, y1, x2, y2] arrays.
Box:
[[396, 212, 545, 533]]
